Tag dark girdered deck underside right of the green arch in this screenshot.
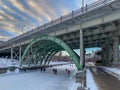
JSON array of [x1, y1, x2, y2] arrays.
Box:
[[58, 20, 120, 49]]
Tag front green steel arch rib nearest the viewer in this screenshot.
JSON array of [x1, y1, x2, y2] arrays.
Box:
[[20, 35, 83, 70]]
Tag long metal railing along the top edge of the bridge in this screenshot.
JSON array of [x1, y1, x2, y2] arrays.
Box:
[[0, 0, 115, 46]]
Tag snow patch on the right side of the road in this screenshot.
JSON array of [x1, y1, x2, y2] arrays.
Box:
[[102, 67, 120, 80]]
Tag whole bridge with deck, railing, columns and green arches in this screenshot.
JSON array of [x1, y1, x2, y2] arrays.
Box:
[[0, 0, 120, 70]]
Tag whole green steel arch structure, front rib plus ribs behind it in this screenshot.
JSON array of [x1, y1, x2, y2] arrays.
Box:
[[20, 35, 82, 70]]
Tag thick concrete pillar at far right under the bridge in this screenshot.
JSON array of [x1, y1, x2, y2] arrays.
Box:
[[113, 37, 119, 66]]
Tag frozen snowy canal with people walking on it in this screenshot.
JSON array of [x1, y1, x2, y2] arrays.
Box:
[[0, 65, 76, 90]]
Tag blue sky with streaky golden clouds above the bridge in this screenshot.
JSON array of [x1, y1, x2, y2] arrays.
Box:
[[0, 0, 95, 41]]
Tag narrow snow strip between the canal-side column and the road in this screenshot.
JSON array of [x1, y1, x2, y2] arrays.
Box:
[[86, 69, 98, 90]]
